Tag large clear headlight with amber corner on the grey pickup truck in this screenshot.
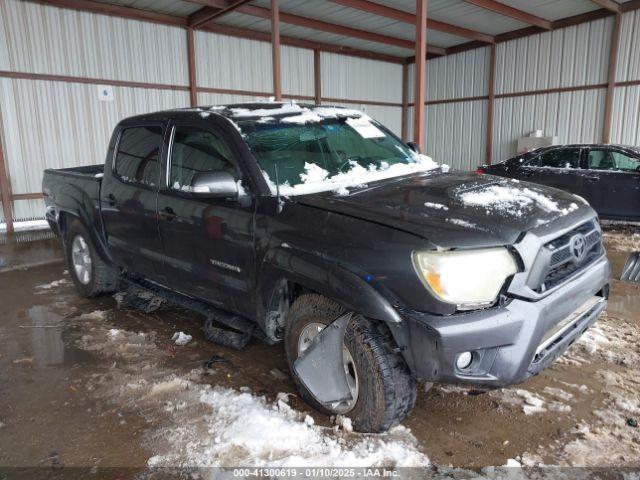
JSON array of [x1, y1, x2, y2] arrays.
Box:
[[413, 247, 518, 310]]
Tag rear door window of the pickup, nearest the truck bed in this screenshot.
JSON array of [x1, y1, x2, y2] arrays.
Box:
[[114, 126, 162, 187]]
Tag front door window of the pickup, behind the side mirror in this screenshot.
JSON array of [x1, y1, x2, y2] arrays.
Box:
[[169, 126, 240, 190]]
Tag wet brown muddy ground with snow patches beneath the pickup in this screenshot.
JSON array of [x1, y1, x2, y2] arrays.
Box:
[[0, 229, 640, 478]]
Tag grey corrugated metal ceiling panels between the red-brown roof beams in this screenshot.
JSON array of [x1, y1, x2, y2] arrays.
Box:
[[36, 0, 637, 61]]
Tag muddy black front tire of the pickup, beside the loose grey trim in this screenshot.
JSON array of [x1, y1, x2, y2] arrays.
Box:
[[285, 294, 417, 433]]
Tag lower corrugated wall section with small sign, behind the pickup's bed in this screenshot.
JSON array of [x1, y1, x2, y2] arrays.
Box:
[[0, 78, 189, 201]]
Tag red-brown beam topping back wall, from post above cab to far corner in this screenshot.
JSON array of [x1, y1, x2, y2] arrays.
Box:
[[202, 23, 405, 64]]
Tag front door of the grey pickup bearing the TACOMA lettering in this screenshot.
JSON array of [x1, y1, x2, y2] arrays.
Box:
[[158, 122, 254, 315]]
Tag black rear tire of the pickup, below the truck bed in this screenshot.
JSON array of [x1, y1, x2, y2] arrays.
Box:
[[64, 220, 119, 298]]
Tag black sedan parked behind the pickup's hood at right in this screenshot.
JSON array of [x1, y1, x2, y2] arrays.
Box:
[[478, 145, 640, 220]]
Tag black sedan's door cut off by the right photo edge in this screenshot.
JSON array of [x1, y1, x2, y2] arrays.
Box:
[[582, 147, 640, 219]]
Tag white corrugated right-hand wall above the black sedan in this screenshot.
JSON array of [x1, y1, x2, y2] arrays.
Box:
[[409, 12, 620, 169]]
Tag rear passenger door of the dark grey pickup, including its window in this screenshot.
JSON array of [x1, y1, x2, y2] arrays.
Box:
[[100, 124, 164, 281]]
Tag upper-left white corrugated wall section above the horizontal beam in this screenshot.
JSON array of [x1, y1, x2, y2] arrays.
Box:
[[0, 0, 189, 85]]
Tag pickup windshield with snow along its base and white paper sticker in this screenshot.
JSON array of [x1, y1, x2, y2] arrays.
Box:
[[238, 116, 438, 195]]
